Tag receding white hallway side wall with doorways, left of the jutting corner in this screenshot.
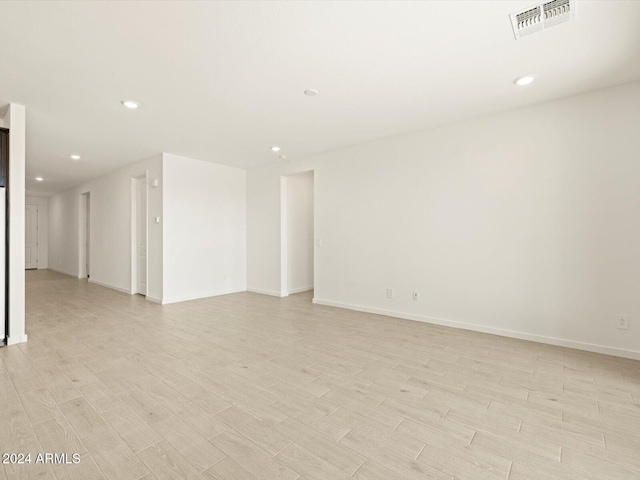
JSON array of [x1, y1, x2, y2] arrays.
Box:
[[49, 155, 163, 301]]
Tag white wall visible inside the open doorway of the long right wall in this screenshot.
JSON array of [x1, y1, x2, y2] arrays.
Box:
[[285, 172, 313, 293]]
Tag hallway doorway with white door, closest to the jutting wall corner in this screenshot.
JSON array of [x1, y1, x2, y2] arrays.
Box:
[[131, 175, 148, 297]]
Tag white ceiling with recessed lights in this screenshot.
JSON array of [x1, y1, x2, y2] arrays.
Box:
[[0, 0, 640, 195]]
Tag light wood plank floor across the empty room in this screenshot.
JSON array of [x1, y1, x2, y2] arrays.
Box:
[[0, 271, 640, 480]]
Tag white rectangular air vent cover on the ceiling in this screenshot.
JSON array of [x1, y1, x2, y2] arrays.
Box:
[[511, 0, 576, 39]]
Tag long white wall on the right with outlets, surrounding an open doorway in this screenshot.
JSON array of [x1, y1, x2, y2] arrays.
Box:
[[247, 83, 640, 358]]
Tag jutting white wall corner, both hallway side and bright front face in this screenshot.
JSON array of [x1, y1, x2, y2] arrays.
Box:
[[49, 154, 246, 303]]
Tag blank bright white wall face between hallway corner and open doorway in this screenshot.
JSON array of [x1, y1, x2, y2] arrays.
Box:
[[163, 153, 246, 303]]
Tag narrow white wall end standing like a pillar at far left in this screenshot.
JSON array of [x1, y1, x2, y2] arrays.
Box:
[[4, 103, 27, 345]]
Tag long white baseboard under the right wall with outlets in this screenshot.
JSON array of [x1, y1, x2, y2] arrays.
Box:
[[313, 298, 640, 360]]
